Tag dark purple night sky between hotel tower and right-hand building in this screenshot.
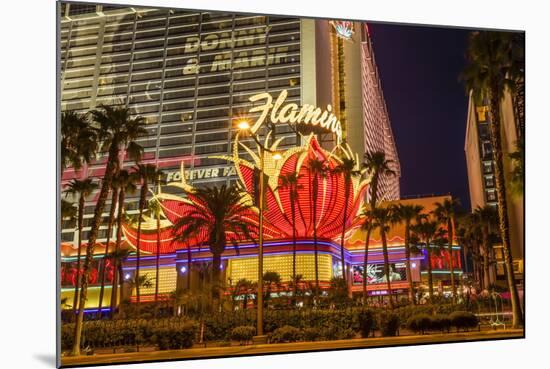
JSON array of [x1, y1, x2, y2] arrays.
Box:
[[369, 23, 470, 209]]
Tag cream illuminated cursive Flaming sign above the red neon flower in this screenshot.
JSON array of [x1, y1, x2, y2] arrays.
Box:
[[249, 90, 342, 144]]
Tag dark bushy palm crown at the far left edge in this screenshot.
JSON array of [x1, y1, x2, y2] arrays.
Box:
[[61, 110, 99, 174]]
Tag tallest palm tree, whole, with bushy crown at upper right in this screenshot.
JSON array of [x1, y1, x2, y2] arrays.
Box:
[[462, 31, 525, 327]]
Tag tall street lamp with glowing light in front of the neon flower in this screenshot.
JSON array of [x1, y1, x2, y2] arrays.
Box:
[[237, 119, 282, 336]]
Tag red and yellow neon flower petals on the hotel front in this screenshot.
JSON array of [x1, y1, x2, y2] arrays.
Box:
[[123, 136, 368, 253]]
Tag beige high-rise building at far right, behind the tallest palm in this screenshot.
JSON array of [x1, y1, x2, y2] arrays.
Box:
[[464, 86, 525, 279]]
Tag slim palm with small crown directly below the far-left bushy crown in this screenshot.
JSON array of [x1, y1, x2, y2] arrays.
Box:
[[65, 178, 98, 314]]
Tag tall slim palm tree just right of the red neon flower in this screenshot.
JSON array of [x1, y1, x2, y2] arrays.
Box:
[[363, 151, 396, 303]]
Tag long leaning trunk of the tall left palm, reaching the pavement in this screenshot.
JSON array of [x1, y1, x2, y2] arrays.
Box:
[[71, 141, 119, 356]]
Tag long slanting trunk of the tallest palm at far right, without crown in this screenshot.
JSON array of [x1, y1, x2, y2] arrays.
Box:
[[490, 89, 523, 328]]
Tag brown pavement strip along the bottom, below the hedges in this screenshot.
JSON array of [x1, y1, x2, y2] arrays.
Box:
[[61, 329, 524, 367]]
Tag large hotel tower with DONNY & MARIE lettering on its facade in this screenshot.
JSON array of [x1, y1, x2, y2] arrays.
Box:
[[59, 3, 400, 308]]
